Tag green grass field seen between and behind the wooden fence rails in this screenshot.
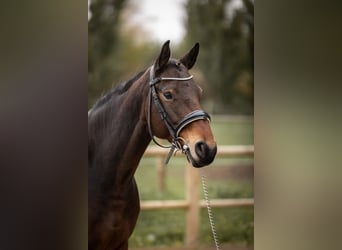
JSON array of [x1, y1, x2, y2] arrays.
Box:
[[130, 117, 254, 247]]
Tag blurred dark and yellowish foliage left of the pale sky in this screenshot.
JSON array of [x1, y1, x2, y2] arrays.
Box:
[[88, 0, 160, 108]]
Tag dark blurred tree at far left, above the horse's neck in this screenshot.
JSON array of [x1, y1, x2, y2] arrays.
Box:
[[88, 0, 126, 106]]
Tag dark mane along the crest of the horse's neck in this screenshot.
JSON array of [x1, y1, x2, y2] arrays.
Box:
[[92, 69, 146, 110]]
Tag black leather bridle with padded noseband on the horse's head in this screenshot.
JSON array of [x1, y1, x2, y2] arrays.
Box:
[[147, 65, 210, 164]]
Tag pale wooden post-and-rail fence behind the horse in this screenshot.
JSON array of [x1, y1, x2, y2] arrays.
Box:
[[141, 145, 254, 247]]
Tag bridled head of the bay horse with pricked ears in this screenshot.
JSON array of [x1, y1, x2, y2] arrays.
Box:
[[147, 41, 217, 167]]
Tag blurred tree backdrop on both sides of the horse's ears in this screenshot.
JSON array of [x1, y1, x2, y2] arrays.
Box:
[[88, 0, 254, 115]]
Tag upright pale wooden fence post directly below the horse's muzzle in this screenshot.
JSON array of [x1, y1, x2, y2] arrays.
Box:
[[185, 164, 200, 248]]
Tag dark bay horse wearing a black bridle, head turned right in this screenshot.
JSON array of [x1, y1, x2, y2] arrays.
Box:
[[88, 41, 216, 250]]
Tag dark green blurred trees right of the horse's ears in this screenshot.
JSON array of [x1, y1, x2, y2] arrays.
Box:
[[185, 0, 254, 113]]
